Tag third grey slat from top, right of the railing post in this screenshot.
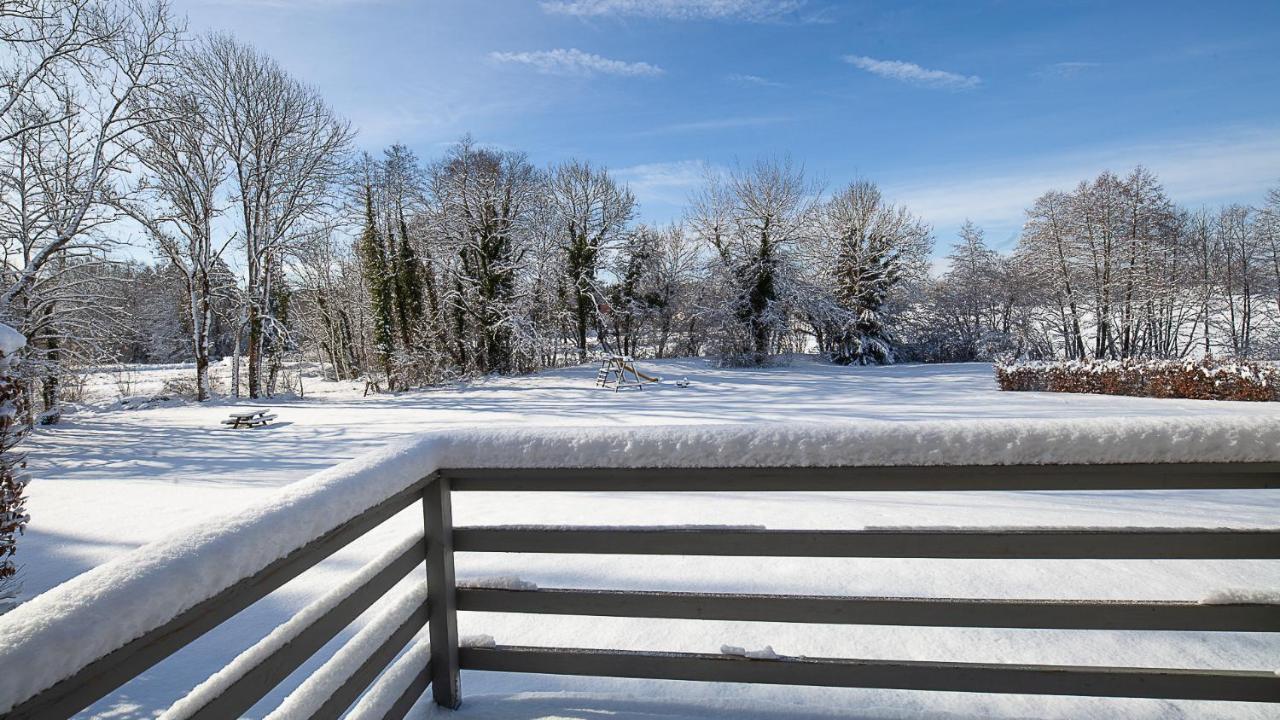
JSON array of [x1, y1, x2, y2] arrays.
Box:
[[458, 587, 1280, 633]]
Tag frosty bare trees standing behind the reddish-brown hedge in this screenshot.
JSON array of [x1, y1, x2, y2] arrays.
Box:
[[909, 168, 1280, 360]]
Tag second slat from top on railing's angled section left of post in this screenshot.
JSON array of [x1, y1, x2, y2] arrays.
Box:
[[179, 542, 426, 720]]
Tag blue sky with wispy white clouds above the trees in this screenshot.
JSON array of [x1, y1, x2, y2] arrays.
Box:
[[177, 0, 1280, 255]]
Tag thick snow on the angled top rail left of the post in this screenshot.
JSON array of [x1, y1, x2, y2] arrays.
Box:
[[0, 430, 434, 711]]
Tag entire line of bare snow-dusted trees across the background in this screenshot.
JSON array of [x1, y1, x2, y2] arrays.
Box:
[[0, 0, 1280, 421]]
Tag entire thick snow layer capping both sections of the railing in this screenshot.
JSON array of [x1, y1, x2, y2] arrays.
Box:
[[0, 416, 1280, 714]]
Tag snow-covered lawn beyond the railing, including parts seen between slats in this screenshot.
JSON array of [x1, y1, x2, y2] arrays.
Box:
[[12, 359, 1280, 719]]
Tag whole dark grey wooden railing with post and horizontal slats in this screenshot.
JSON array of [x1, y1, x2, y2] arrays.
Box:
[[5, 462, 1280, 720]]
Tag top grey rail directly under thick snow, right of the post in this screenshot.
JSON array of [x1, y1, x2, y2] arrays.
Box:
[[440, 462, 1280, 492]]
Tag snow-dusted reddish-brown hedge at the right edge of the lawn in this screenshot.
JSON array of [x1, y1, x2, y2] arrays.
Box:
[[996, 357, 1280, 401]]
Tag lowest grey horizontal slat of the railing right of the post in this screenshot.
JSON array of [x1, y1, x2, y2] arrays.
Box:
[[460, 646, 1280, 702]]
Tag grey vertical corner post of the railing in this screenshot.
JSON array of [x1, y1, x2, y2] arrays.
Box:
[[422, 475, 462, 708]]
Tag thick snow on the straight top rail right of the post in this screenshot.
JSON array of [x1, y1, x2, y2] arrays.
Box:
[[421, 418, 1280, 468]]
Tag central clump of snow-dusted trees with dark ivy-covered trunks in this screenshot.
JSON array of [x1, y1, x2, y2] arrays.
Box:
[[302, 146, 932, 389]]
